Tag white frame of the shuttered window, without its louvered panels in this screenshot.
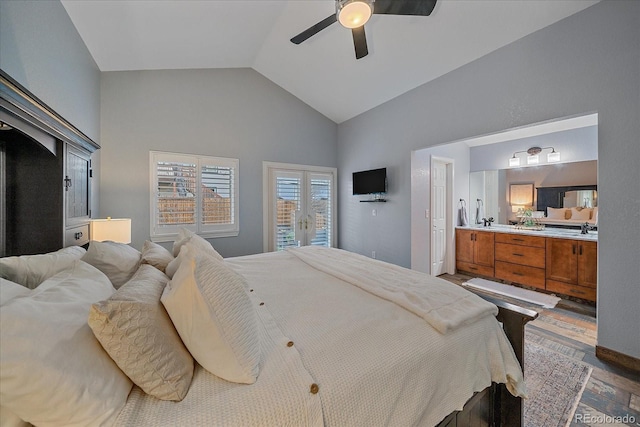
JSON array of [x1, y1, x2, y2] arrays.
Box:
[[149, 150, 240, 242]]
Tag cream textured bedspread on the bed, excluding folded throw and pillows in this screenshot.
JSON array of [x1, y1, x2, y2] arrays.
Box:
[[117, 251, 524, 426]]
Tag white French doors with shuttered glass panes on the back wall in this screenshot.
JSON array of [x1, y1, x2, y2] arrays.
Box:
[[263, 162, 336, 251]]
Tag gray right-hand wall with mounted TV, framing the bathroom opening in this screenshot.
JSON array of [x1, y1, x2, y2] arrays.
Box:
[[338, 0, 640, 357]]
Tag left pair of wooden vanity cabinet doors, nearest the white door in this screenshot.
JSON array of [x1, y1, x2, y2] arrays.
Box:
[[456, 229, 495, 277]]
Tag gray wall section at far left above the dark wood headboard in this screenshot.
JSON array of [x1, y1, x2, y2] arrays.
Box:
[[0, 0, 100, 224]]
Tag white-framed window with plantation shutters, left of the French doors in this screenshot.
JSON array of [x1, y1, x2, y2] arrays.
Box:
[[149, 151, 239, 241]]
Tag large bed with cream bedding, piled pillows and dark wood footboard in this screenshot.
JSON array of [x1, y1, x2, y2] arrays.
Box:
[[0, 232, 527, 426]]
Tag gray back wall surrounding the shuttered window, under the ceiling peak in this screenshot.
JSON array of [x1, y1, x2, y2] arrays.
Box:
[[100, 69, 337, 256]]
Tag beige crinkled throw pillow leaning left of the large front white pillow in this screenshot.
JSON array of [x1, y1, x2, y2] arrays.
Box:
[[89, 264, 194, 401]]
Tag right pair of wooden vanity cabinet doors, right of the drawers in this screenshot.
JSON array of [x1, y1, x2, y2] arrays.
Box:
[[546, 239, 598, 301]]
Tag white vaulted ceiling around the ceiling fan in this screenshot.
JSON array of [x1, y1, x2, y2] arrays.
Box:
[[62, 0, 597, 123]]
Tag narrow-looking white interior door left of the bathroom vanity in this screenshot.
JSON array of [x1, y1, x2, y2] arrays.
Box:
[[431, 159, 447, 276]]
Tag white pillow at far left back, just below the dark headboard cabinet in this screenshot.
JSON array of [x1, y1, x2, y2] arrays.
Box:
[[0, 246, 86, 289]]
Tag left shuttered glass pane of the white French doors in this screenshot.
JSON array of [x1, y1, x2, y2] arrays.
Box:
[[276, 176, 302, 251]]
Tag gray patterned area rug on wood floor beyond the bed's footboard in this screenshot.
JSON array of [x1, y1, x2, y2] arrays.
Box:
[[524, 342, 592, 427]]
